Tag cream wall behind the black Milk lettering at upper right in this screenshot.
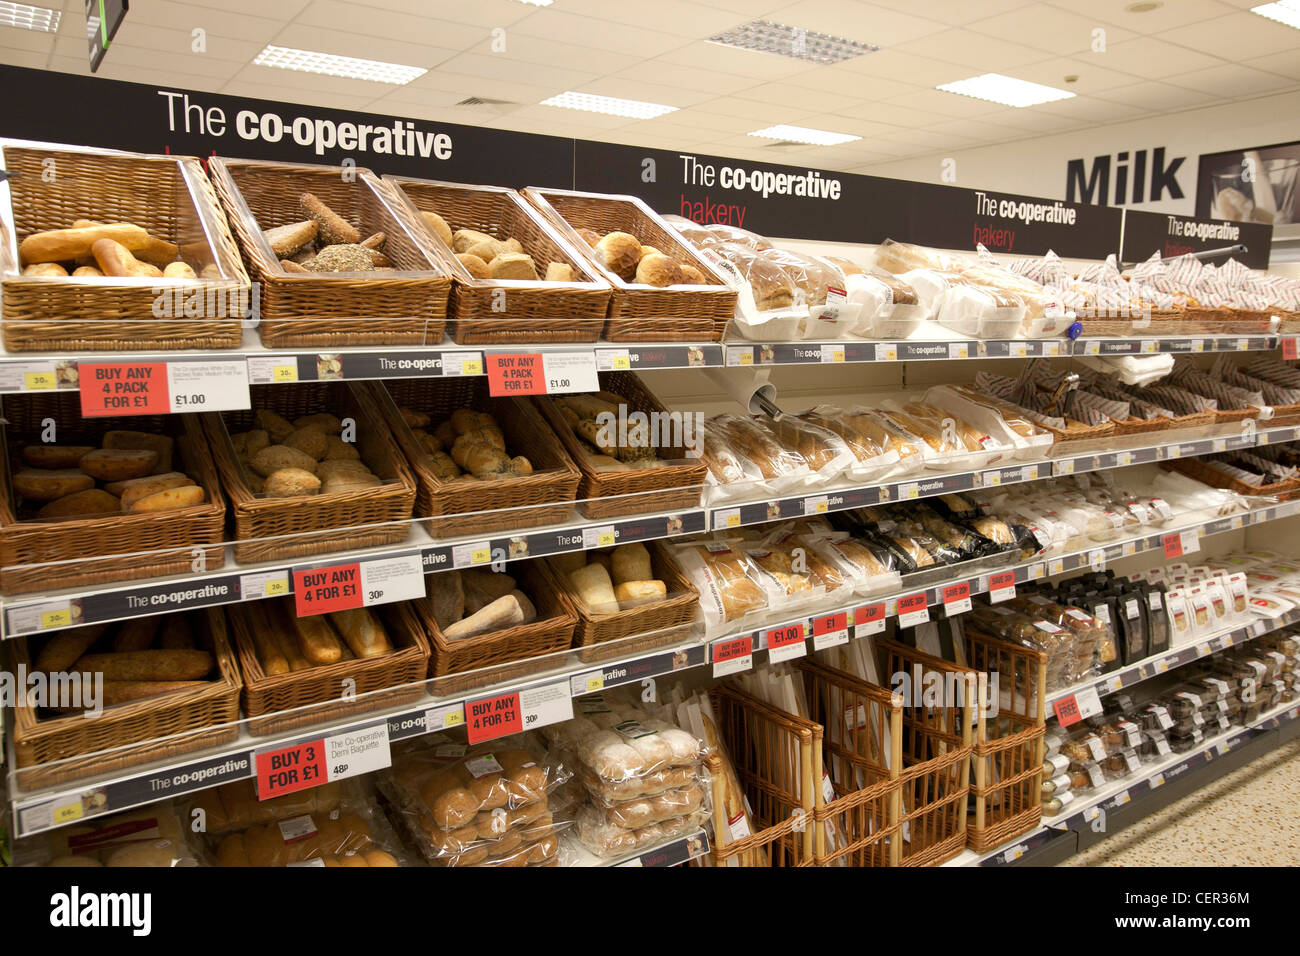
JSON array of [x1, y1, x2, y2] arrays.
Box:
[[861, 92, 1300, 216]]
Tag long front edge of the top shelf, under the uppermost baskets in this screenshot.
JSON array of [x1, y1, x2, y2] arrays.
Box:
[[0, 330, 1279, 393]]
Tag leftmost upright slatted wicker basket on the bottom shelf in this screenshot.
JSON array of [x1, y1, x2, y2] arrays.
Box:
[[709, 684, 822, 866]]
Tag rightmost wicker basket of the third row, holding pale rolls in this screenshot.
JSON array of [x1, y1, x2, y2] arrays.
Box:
[[541, 542, 699, 661]]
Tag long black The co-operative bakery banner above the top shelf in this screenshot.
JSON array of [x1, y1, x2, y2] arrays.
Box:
[[0, 66, 1269, 265]]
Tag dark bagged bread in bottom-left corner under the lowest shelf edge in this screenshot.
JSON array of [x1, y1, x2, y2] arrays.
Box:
[[22, 797, 200, 868]]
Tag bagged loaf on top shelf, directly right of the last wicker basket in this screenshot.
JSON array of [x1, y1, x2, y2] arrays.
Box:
[[702, 242, 809, 342]]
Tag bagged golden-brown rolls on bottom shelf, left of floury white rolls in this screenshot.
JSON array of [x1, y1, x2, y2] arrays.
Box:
[[380, 734, 571, 866]]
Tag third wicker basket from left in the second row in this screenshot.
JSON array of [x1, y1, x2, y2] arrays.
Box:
[[368, 376, 581, 537]]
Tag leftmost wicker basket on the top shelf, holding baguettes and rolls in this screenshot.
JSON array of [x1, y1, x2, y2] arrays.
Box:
[[0, 139, 250, 351]]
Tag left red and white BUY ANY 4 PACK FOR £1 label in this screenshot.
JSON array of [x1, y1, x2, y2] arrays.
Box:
[[79, 359, 251, 418]]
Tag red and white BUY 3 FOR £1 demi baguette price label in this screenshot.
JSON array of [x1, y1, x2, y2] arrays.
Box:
[[256, 721, 393, 800]]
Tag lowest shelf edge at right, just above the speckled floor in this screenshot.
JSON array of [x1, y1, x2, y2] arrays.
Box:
[[944, 702, 1300, 866]]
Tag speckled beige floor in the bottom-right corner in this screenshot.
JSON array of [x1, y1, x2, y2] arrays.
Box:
[[1063, 740, 1300, 866]]
